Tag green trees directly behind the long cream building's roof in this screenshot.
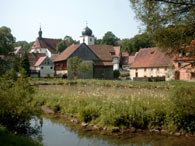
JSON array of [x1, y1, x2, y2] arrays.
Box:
[[121, 33, 155, 53]]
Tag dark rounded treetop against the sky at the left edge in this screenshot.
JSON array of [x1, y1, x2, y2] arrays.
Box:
[[0, 26, 15, 55]]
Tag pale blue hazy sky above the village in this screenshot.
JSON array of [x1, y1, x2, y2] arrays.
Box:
[[0, 0, 139, 42]]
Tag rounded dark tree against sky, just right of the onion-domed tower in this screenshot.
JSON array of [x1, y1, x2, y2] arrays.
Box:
[[101, 31, 119, 46]]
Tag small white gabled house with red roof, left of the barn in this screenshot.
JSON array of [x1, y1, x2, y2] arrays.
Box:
[[27, 53, 55, 77]]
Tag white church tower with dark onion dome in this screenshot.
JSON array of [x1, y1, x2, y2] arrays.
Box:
[[80, 26, 95, 45]]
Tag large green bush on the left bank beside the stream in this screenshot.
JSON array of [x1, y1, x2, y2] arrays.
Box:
[[0, 70, 34, 133]]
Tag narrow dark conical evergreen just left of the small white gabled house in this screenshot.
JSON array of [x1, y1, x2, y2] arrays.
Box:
[[19, 53, 31, 76]]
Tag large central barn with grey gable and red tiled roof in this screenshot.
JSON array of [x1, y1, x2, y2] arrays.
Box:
[[54, 43, 115, 79]]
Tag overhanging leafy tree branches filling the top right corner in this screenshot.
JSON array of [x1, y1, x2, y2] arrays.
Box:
[[130, 0, 195, 54]]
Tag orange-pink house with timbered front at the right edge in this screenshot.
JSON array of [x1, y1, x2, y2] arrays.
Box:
[[174, 40, 195, 81]]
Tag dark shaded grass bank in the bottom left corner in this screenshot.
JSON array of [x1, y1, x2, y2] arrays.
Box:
[[0, 125, 41, 146]]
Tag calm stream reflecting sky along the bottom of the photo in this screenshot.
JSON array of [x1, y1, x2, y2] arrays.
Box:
[[32, 118, 195, 146]]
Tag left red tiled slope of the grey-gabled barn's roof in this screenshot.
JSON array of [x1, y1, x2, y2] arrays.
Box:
[[54, 44, 80, 62]]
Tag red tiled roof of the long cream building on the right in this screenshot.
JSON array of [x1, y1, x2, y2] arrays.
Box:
[[131, 48, 173, 68]]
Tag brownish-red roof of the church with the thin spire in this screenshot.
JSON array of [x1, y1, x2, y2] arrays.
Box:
[[32, 38, 70, 54]]
